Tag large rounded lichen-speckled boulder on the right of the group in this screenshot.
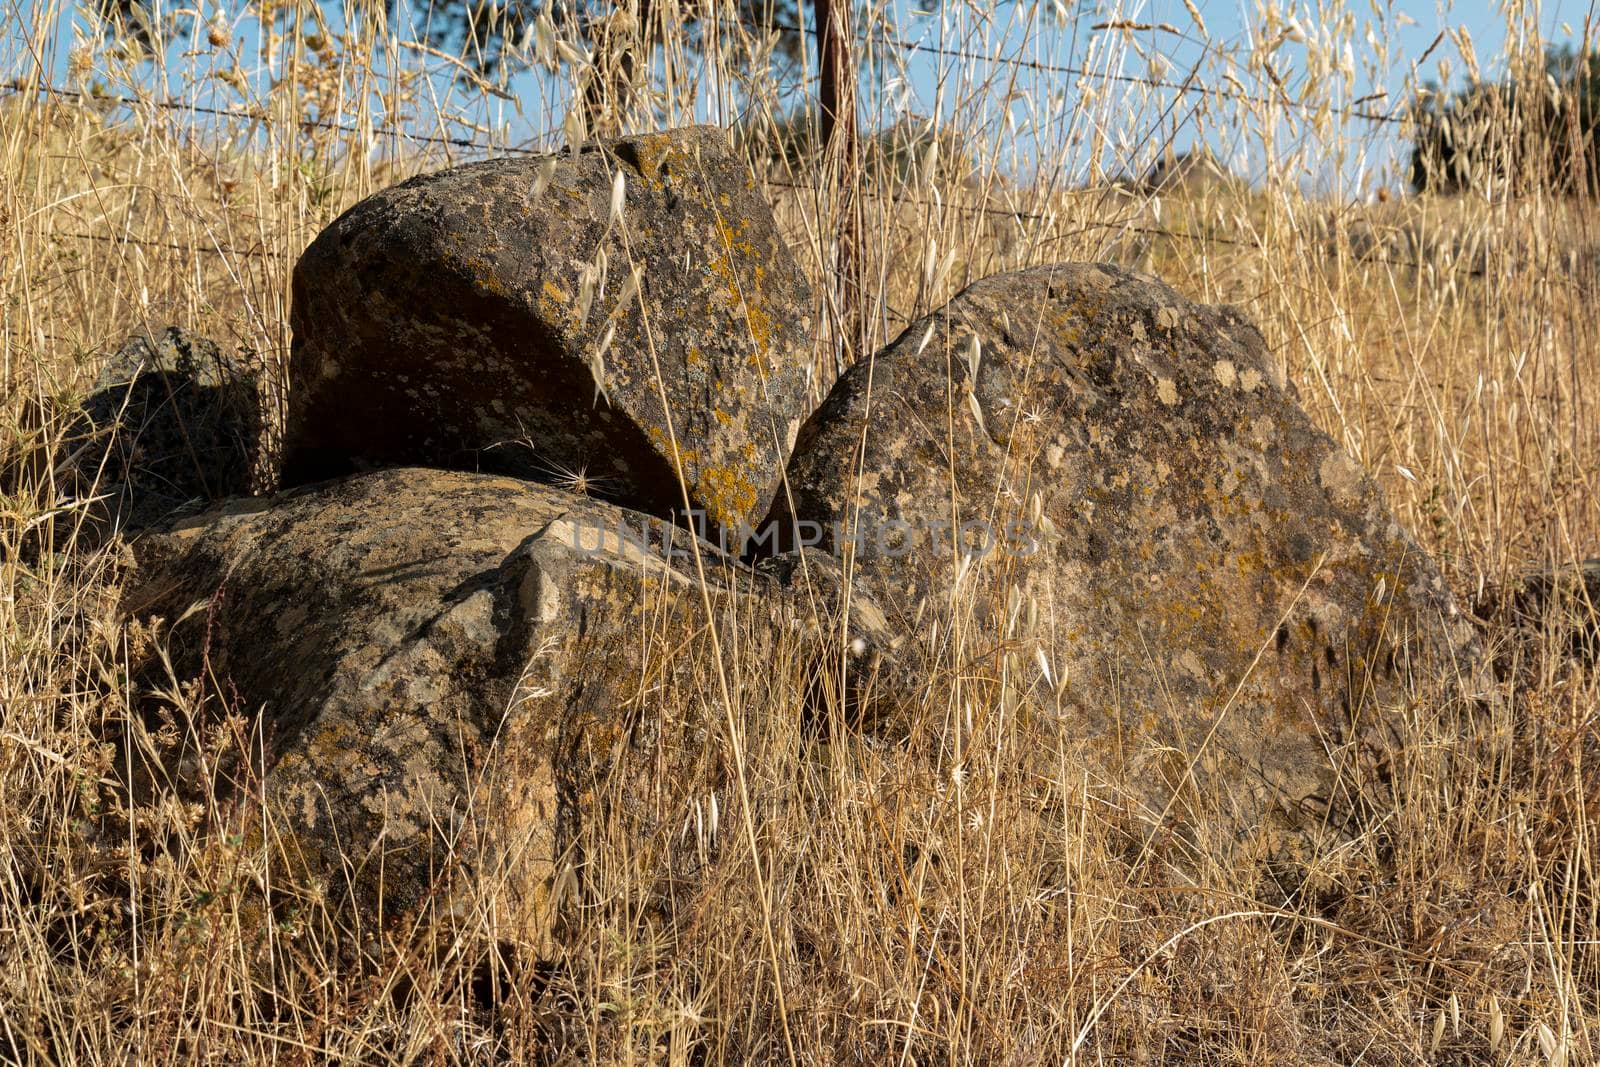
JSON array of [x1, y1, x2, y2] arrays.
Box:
[[773, 264, 1470, 829]]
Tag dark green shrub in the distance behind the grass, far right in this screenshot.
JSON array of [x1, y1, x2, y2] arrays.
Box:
[[1410, 45, 1600, 195]]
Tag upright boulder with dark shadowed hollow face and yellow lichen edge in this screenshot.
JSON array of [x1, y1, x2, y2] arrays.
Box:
[[285, 126, 811, 543]]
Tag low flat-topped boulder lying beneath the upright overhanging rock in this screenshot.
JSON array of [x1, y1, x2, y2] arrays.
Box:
[[125, 469, 888, 944]]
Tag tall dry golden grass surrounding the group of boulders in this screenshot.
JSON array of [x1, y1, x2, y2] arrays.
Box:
[[0, 5, 1600, 1064]]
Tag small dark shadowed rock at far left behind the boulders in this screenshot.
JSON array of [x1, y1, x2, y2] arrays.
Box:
[[59, 326, 261, 531]]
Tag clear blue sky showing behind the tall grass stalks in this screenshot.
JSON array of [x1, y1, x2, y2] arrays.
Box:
[[15, 0, 1595, 197]]
